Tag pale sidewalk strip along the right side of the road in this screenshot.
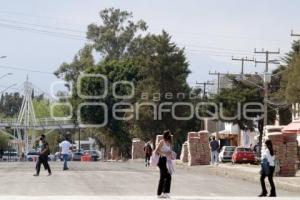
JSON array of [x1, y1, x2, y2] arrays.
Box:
[[205, 163, 300, 191]]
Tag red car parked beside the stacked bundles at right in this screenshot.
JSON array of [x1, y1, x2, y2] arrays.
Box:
[[231, 147, 255, 164]]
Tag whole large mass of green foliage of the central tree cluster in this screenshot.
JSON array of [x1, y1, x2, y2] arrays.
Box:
[[55, 8, 200, 157]]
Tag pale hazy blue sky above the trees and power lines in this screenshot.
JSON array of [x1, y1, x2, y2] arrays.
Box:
[[0, 0, 300, 94]]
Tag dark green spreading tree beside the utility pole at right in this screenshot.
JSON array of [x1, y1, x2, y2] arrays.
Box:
[[212, 76, 266, 153]]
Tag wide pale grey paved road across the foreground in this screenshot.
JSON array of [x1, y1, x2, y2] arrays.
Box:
[[0, 161, 300, 199]]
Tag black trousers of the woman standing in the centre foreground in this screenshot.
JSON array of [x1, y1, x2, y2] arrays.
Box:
[[157, 157, 172, 196]]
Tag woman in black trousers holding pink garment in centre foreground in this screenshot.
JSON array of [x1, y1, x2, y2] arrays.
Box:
[[155, 130, 173, 198]]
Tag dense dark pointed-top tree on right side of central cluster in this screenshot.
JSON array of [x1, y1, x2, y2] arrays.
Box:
[[131, 31, 200, 152]]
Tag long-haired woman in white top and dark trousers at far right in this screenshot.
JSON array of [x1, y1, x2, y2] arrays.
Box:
[[259, 140, 276, 197]]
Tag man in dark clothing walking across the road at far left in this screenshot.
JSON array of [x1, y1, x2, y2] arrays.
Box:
[[34, 135, 52, 176]]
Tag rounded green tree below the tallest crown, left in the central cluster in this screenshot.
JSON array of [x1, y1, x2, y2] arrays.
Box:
[[81, 58, 137, 157]]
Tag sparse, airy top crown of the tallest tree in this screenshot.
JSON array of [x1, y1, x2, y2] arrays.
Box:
[[87, 8, 147, 59]]
